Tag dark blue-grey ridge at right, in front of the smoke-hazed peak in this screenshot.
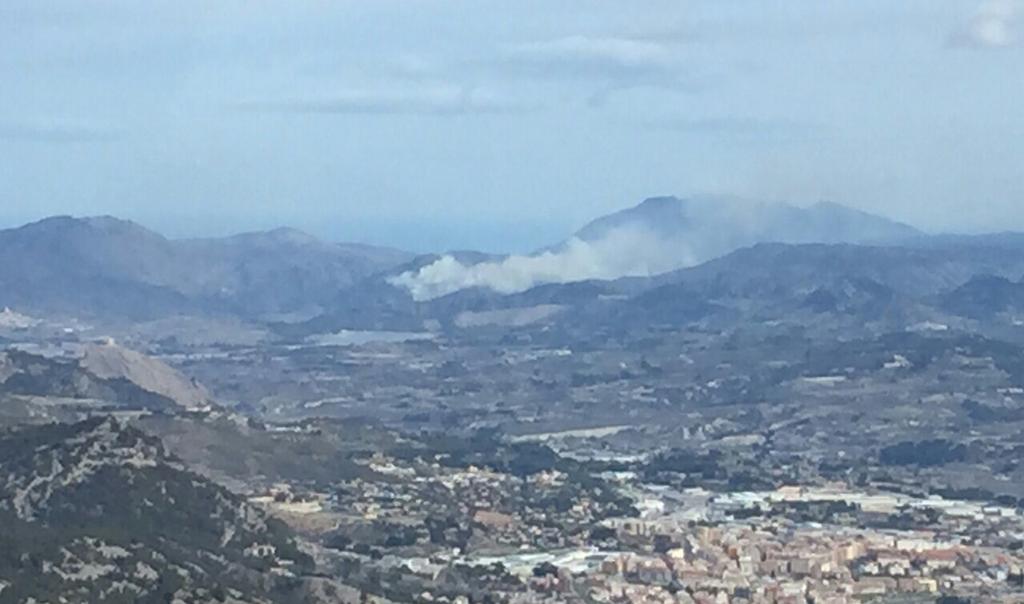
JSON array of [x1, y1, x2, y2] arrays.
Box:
[[585, 244, 1024, 328]]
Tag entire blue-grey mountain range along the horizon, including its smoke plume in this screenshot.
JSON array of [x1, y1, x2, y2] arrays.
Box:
[[0, 198, 1024, 337]]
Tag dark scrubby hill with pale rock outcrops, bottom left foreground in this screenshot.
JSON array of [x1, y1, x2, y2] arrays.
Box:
[[0, 419, 311, 602]]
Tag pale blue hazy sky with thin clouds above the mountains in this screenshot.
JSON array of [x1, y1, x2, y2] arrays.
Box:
[[0, 0, 1024, 251]]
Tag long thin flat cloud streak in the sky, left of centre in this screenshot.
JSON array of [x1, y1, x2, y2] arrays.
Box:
[[237, 86, 534, 116]]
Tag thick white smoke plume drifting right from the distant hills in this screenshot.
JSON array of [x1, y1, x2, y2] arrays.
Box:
[[389, 227, 696, 301]]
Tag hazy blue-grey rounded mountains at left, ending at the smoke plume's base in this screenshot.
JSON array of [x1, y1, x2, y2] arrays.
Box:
[[0, 216, 412, 319]]
